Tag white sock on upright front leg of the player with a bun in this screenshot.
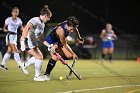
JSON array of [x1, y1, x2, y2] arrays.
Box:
[[35, 60, 42, 77]]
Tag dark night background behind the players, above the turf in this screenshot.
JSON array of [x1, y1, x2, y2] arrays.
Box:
[[0, 0, 140, 59]]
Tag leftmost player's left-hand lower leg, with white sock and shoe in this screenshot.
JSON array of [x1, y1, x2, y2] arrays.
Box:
[[0, 46, 12, 70]]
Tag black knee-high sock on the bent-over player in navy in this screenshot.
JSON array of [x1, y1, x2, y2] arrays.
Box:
[[44, 58, 56, 75]]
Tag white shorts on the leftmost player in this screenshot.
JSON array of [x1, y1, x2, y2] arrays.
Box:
[[6, 33, 17, 45]]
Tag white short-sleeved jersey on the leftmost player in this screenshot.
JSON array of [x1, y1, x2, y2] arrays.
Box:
[[5, 17, 22, 33]]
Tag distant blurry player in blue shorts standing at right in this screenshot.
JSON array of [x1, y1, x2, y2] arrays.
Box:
[[100, 23, 117, 63]]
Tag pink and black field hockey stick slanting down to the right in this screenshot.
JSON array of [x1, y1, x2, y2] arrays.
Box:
[[55, 52, 81, 80]]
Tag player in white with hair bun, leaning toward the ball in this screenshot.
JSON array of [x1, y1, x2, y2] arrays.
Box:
[[21, 6, 52, 81]]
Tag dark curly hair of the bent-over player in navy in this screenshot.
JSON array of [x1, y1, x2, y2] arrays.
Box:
[[67, 16, 79, 28]]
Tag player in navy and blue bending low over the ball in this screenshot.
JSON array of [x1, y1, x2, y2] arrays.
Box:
[[44, 17, 83, 80]]
